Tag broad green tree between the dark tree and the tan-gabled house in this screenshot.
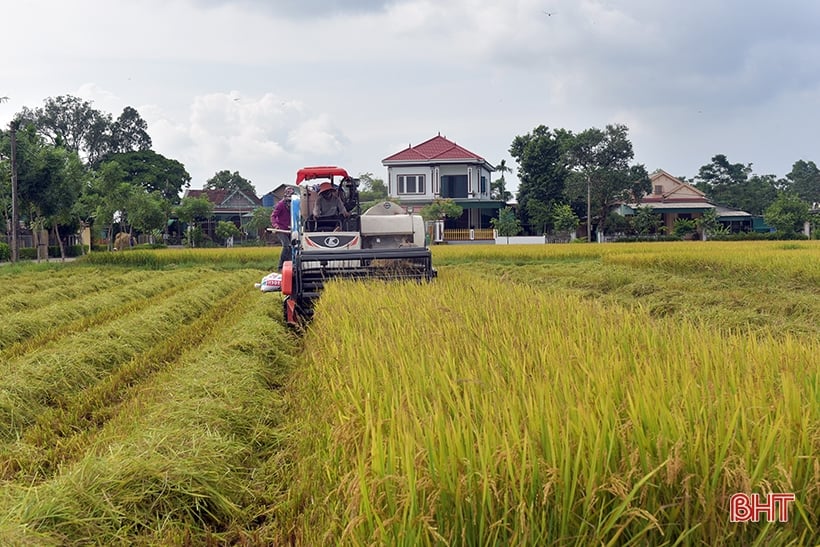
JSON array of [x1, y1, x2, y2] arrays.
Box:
[[566, 124, 651, 242]]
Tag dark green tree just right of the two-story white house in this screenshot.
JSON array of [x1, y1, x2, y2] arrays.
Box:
[[510, 125, 573, 229]]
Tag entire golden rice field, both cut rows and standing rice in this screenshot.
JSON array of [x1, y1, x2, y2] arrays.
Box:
[[0, 242, 820, 545]]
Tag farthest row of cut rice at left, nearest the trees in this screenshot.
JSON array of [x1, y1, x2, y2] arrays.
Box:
[[0, 265, 157, 315]]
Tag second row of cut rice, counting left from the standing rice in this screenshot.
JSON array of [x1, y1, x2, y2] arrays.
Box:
[[0, 272, 253, 441]]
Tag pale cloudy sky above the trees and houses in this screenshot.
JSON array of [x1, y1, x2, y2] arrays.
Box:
[[0, 0, 820, 195]]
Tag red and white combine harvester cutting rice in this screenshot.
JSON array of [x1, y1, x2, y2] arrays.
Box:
[[282, 166, 436, 326]]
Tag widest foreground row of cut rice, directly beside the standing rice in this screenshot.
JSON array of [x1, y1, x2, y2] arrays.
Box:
[[0, 284, 293, 545]]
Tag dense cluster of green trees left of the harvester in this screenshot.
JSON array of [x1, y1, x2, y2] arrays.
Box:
[[0, 95, 266, 256]]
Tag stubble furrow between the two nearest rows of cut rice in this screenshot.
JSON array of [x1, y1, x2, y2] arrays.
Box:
[[0, 277, 260, 484]]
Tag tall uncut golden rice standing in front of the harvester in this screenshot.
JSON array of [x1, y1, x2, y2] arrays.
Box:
[[272, 271, 820, 545]]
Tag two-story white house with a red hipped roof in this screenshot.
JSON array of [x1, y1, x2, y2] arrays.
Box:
[[382, 134, 505, 240]]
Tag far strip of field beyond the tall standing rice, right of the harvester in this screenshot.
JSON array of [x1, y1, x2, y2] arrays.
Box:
[[434, 241, 820, 337]]
